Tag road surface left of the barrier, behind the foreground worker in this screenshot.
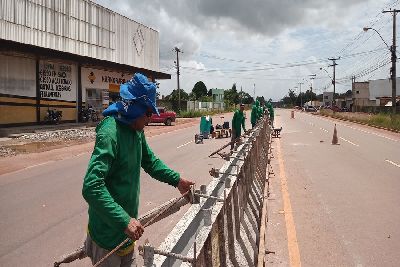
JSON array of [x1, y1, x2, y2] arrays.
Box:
[[0, 113, 250, 266]]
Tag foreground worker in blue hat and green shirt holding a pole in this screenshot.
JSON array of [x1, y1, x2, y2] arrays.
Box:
[[82, 74, 194, 267]]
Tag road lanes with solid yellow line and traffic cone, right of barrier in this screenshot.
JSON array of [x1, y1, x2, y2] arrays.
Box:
[[266, 110, 400, 266]]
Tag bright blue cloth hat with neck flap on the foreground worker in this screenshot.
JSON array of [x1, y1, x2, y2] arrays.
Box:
[[103, 73, 160, 124]]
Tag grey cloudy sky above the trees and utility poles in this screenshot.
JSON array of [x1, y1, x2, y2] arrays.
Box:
[[95, 0, 400, 100]]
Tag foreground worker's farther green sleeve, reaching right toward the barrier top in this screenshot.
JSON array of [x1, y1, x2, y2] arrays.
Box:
[[142, 133, 180, 187]]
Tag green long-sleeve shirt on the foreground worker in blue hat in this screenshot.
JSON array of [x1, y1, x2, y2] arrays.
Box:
[[82, 117, 180, 250]]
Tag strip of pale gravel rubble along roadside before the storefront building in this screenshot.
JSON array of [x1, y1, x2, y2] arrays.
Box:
[[16, 128, 96, 142]]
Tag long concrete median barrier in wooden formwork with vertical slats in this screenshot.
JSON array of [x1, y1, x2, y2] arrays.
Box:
[[142, 119, 271, 266]]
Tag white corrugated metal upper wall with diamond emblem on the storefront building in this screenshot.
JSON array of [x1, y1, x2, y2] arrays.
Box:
[[0, 0, 159, 71]]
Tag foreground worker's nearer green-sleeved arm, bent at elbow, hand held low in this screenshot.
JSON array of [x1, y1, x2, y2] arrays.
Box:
[[82, 133, 131, 231]]
